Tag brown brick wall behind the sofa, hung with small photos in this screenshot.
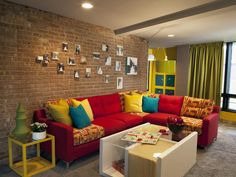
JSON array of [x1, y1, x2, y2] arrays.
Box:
[[0, 0, 147, 162]]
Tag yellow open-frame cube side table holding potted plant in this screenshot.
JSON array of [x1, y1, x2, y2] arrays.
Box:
[[8, 134, 55, 177]]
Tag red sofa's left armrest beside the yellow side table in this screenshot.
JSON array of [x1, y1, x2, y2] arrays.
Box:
[[48, 121, 74, 162]]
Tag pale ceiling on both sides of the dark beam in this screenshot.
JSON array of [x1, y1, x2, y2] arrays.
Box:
[[9, 0, 236, 47]]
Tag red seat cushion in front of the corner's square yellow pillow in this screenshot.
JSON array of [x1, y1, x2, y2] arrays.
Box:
[[104, 112, 143, 128]]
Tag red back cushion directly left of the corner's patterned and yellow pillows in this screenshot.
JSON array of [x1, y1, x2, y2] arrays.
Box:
[[101, 93, 122, 115]]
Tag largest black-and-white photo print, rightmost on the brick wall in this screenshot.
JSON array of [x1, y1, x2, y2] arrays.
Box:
[[125, 57, 138, 75]]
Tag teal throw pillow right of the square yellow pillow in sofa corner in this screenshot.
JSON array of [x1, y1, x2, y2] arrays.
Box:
[[142, 96, 159, 113]]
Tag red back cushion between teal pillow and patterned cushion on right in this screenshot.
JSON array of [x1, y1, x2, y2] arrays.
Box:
[[158, 95, 184, 116]]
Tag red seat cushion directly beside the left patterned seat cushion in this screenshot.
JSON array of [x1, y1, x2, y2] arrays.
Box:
[[92, 117, 126, 136]]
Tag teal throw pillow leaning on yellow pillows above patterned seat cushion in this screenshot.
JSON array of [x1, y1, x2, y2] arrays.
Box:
[[69, 105, 91, 128]]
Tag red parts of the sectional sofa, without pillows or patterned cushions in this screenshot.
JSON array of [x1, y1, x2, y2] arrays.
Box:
[[34, 93, 219, 162]]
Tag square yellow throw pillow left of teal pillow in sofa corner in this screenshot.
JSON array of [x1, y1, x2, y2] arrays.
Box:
[[125, 94, 143, 112]]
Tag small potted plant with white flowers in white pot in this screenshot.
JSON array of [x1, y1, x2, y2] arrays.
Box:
[[30, 122, 48, 140]]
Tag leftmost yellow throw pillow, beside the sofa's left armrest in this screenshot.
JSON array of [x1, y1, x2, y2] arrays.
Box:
[[48, 100, 72, 126]]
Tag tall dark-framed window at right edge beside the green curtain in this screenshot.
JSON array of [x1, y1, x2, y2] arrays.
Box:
[[221, 42, 236, 112]]
